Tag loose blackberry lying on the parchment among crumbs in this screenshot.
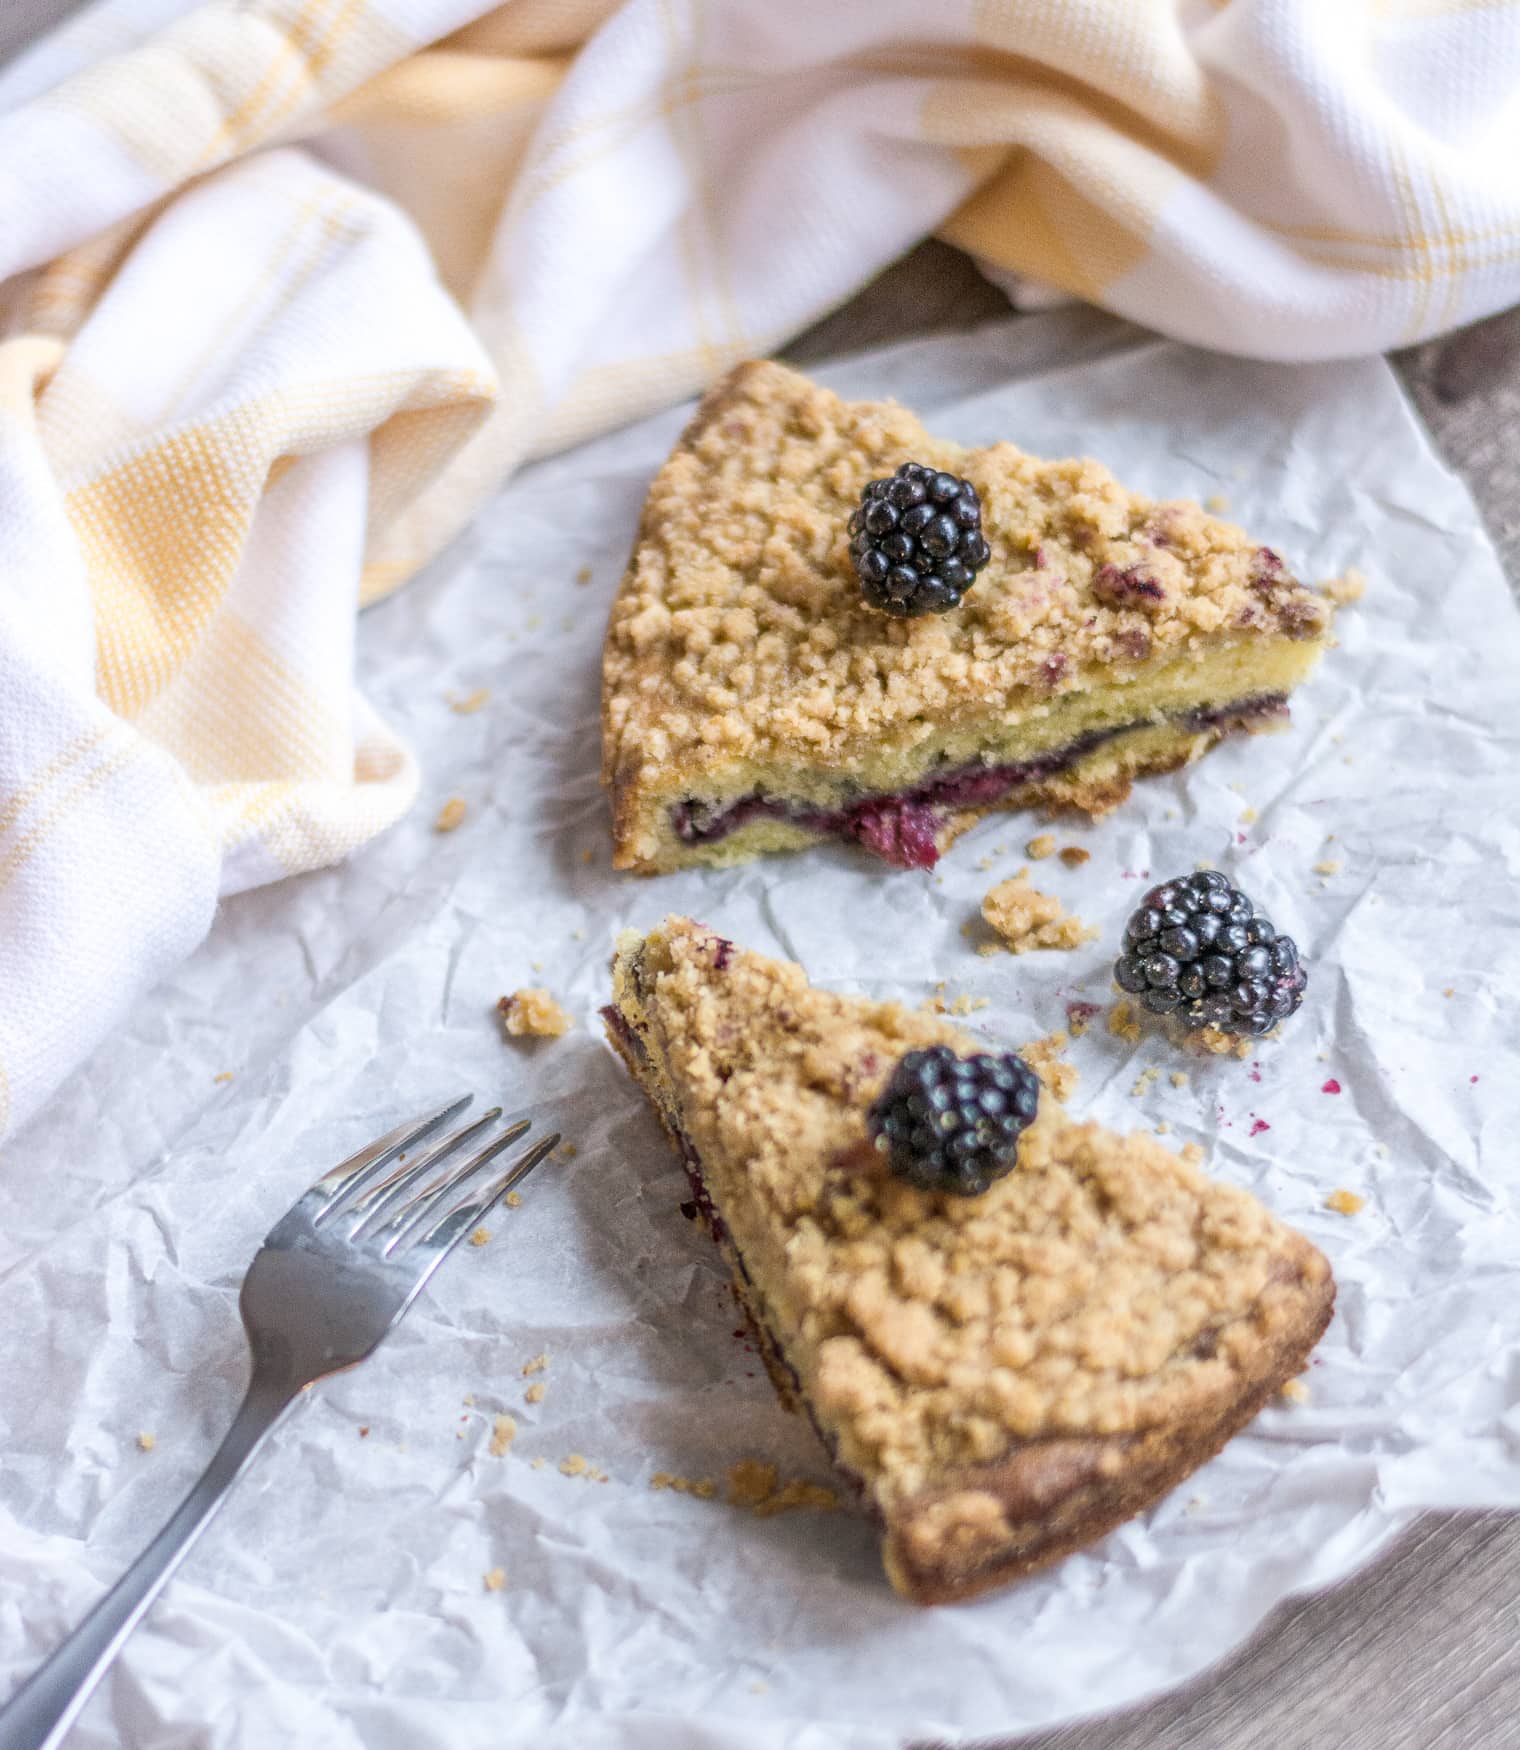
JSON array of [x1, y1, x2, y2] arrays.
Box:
[[1114, 870, 1308, 1034]]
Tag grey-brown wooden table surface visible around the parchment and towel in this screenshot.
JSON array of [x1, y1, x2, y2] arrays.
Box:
[[0, 0, 1520, 1750]]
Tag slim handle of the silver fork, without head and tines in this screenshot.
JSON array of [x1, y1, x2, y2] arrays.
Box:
[[0, 1370, 299, 1750]]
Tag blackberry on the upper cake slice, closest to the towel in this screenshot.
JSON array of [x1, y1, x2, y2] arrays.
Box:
[[850, 462, 992, 620]]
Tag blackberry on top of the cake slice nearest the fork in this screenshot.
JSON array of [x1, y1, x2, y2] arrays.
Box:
[[866, 1045, 1039, 1197]]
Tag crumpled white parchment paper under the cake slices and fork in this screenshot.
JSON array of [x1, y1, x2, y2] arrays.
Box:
[[0, 312, 1520, 1750]]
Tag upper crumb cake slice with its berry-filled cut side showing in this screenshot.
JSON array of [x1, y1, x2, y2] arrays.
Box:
[[603, 362, 1329, 873]]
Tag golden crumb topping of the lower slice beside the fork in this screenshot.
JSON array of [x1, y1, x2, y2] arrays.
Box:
[[616, 919, 1329, 1505]]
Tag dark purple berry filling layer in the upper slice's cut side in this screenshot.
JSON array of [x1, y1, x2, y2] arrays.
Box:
[[670, 693, 1287, 870]]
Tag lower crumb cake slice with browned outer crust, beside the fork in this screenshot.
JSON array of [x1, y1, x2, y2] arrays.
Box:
[[603, 919, 1335, 1603]]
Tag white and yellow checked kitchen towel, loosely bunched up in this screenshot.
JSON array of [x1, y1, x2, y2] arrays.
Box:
[[0, 0, 1520, 1136]]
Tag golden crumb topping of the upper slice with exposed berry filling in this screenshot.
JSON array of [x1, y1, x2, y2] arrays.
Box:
[[603, 362, 1331, 801]]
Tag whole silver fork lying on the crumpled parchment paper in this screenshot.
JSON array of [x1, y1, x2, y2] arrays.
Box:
[[0, 1094, 560, 1750]]
